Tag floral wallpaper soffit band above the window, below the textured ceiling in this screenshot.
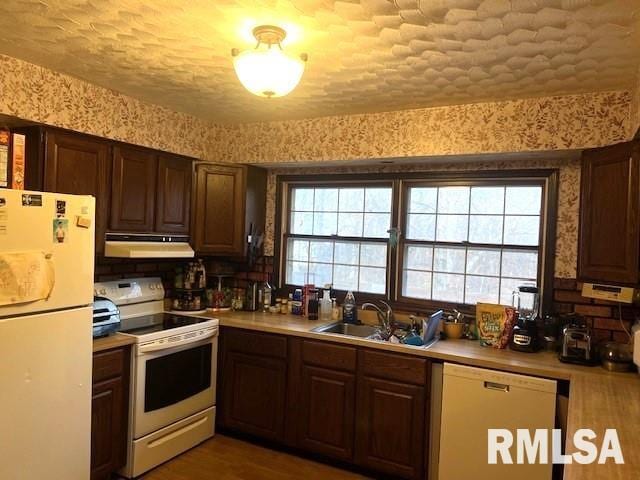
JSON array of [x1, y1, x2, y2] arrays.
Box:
[[223, 91, 632, 164]]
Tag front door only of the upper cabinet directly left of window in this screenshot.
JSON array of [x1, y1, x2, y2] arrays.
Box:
[[193, 163, 246, 255]]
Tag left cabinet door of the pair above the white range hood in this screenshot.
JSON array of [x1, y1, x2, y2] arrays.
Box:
[[111, 146, 158, 232]]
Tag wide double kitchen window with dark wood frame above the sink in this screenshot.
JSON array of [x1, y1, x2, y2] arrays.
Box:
[[277, 170, 558, 308]]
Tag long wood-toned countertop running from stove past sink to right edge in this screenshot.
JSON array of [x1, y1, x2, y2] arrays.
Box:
[[207, 312, 640, 480]]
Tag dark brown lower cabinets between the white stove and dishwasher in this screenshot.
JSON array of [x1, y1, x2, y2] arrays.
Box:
[[218, 328, 430, 480]]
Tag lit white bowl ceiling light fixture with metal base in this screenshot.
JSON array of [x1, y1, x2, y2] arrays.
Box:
[[231, 25, 308, 98]]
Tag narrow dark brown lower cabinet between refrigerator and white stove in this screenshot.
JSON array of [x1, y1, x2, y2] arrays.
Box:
[[91, 346, 130, 480]]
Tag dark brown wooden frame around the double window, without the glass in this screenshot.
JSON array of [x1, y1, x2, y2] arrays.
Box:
[[274, 168, 559, 314]]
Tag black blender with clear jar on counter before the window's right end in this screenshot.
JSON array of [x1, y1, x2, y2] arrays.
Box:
[[509, 284, 540, 353]]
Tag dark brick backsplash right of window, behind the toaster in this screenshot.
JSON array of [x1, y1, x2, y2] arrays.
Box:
[[553, 278, 640, 343]]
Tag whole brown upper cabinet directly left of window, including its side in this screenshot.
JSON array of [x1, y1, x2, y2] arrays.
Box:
[[192, 163, 266, 256]]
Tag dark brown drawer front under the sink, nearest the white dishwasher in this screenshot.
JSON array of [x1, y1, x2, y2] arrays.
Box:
[[359, 350, 427, 385]]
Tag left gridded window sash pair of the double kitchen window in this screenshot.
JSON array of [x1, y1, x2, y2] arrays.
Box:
[[285, 184, 392, 294]]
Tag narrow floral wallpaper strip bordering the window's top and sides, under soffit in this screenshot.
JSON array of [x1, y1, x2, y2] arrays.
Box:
[[264, 155, 580, 278]]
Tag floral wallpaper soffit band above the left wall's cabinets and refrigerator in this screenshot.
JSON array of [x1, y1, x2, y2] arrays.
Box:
[[0, 55, 223, 158]]
